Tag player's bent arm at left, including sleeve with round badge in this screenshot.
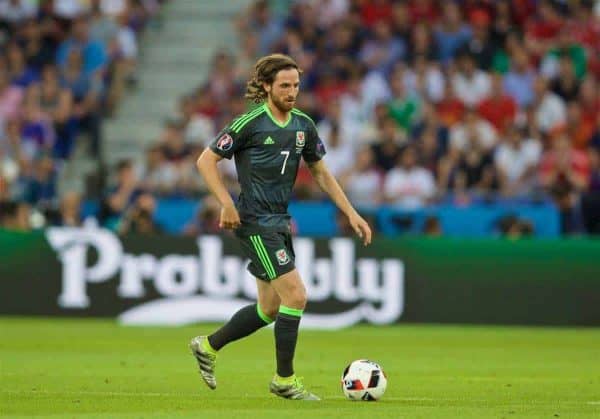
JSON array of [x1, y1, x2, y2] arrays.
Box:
[[196, 125, 242, 229]]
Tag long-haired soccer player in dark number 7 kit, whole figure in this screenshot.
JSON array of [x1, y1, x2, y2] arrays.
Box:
[[190, 54, 371, 400]]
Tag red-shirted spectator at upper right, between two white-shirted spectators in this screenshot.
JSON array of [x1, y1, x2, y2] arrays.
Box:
[[477, 73, 517, 132]]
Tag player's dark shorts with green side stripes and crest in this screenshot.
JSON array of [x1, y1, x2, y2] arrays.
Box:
[[235, 229, 296, 281]]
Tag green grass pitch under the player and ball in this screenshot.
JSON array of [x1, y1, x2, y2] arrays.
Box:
[[0, 317, 600, 419]]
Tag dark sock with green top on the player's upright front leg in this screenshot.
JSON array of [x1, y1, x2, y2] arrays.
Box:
[[275, 305, 302, 377]]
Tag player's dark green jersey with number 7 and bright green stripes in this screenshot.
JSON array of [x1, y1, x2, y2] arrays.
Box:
[[209, 104, 325, 231]]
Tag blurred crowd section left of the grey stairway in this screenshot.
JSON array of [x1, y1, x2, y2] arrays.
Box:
[[0, 0, 162, 228]]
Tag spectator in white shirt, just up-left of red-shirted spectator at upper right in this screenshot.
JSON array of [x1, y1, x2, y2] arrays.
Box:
[[452, 52, 491, 107]]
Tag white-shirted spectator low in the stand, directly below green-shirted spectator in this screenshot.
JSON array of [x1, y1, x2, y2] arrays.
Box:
[[383, 146, 435, 210]]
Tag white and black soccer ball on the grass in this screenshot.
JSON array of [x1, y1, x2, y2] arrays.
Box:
[[342, 359, 387, 401]]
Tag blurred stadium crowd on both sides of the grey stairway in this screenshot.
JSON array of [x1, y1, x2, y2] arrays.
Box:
[[0, 0, 600, 234]]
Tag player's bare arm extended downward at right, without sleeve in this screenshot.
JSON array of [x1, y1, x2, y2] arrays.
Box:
[[308, 160, 372, 246]]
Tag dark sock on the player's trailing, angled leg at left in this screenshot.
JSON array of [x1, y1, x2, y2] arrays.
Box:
[[208, 304, 273, 351]]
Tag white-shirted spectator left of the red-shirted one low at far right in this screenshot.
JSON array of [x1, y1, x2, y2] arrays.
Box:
[[494, 125, 542, 196]]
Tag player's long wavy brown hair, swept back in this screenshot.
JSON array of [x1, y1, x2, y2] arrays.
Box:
[[245, 54, 302, 103]]
